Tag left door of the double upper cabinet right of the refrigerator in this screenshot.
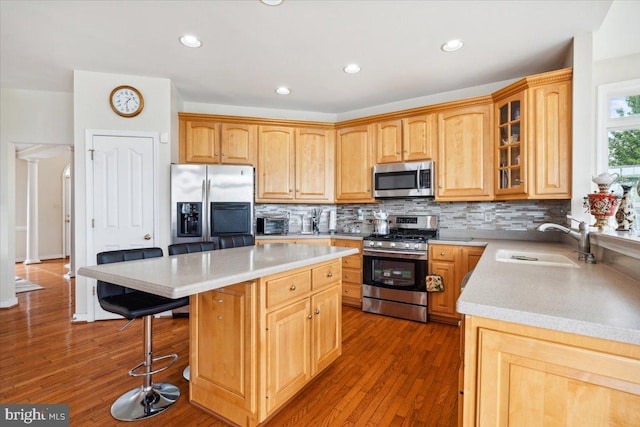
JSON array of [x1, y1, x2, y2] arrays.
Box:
[[256, 126, 295, 201]]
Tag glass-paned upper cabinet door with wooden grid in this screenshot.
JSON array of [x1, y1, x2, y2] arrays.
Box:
[[495, 91, 527, 195]]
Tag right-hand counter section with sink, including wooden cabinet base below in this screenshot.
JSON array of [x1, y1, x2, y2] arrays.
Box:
[[457, 240, 640, 426]]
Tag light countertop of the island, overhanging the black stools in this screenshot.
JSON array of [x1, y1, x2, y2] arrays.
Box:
[[78, 243, 358, 298]]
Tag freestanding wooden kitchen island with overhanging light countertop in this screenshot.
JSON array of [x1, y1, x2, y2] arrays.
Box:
[[78, 243, 357, 426]]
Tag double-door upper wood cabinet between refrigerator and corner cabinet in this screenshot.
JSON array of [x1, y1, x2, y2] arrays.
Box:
[[256, 126, 334, 203]]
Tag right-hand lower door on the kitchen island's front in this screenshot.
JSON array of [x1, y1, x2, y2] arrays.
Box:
[[311, 285, 342, 375]]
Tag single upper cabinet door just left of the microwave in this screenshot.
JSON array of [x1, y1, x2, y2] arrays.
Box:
[[336, 126, 374, 203]]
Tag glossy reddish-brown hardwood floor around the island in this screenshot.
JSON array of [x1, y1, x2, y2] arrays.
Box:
[[0, 260, 459, 427]]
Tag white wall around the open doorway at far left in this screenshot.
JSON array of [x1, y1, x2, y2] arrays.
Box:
[[0, 88, 73, 307]]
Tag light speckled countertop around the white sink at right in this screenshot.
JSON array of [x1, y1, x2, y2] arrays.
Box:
[[457, 240, 640, 345]]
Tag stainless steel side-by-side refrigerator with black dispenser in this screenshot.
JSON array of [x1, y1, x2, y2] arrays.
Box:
[[171, 164, 254, 244]]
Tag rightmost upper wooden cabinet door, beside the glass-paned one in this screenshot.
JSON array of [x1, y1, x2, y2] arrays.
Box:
[[529, 82, 571, 199]]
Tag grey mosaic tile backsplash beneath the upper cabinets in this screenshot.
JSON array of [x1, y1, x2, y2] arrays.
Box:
[[255, 198, 571, 233]]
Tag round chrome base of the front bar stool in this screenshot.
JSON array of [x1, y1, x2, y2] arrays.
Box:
[[111, 383, 180, 421]]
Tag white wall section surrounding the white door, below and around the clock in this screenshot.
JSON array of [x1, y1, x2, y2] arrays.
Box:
[[74, 70, 177, 320]]
